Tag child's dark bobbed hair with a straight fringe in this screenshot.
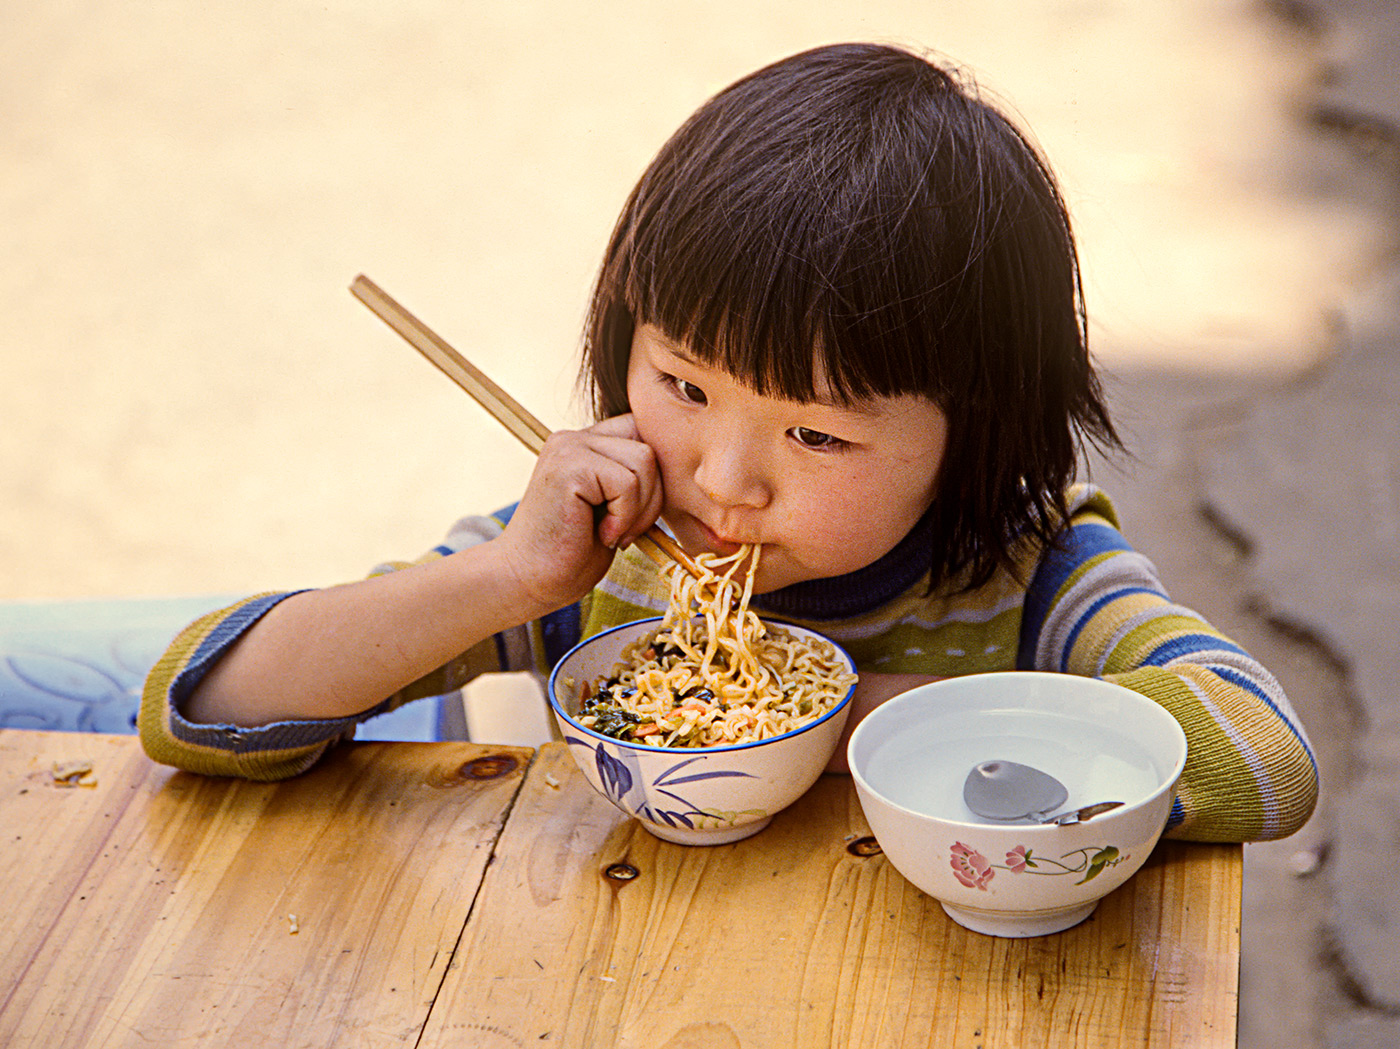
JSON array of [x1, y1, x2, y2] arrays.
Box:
[[584, 43, 1121, 585]]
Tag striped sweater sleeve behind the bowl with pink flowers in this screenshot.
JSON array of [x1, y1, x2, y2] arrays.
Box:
[[1019, 487, 1317, 842]]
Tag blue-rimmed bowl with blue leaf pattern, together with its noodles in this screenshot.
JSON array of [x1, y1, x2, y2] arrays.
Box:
[[549, 550, 855, 845]]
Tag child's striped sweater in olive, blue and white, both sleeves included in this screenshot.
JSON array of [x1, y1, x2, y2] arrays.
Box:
[[140, 486, 1317, 842]]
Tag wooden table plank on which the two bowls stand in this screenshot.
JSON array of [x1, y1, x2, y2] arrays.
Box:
[[423, 744, 1242, 1049]]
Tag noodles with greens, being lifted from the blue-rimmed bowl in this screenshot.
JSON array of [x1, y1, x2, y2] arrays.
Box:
[[577, 546, 855, 746]]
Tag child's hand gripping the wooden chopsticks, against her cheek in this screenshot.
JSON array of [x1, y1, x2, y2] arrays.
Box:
[[496, 415, 662, 615]]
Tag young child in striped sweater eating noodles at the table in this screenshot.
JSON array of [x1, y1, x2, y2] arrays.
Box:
[[140, 45, 1317, 840]]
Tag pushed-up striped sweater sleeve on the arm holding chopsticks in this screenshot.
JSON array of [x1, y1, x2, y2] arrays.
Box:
[[137, 511, 539, 780]]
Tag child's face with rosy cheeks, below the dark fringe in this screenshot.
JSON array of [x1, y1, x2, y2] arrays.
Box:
[[627, 325, 948, 592]]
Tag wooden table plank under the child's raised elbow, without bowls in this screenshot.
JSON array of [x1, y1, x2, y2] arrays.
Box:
[[0, 731, 531, 1049]]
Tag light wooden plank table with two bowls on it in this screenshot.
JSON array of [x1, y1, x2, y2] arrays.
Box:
[[0, 730, 1242, 1049]]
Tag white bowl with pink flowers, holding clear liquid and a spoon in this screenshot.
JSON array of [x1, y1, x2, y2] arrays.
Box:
[[847, 671, 1186, 937]]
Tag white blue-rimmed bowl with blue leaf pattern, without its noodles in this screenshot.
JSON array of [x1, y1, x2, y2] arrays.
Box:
[[549, 616, 854, 845]]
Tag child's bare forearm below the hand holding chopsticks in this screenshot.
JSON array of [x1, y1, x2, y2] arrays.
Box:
[[190, 543, 550, 727]]
